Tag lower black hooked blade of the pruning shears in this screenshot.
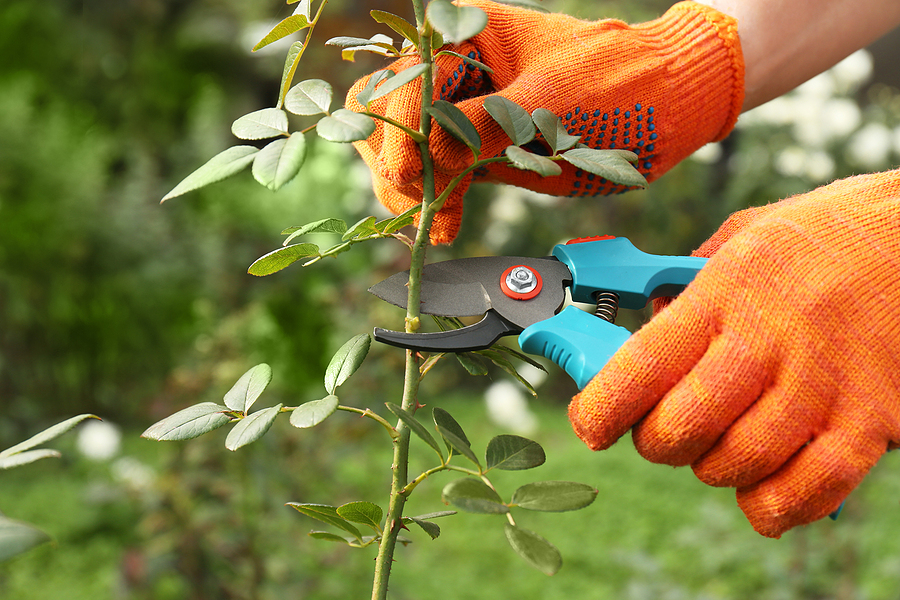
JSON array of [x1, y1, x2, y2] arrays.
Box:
[[375, 310, 522, 352]]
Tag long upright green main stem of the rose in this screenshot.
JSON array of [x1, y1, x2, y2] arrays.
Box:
[[372, 0, 435, 600]]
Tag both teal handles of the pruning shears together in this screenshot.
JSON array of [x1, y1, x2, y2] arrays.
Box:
[[519, 238, 707, 389]]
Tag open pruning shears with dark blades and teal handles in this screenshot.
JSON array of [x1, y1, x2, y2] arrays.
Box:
[[369, 236, 707, 389]]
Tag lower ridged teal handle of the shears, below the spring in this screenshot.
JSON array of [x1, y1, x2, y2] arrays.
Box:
[[519, 306, 631, 389]]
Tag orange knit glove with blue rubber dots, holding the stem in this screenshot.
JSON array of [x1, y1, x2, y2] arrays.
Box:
[[346, 0, 743, 243]]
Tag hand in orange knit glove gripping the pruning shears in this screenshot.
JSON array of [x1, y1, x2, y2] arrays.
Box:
[[569, 170, 900, 537]]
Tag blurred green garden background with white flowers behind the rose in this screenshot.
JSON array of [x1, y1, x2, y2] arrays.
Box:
[[0, 0, 900, 599]]
